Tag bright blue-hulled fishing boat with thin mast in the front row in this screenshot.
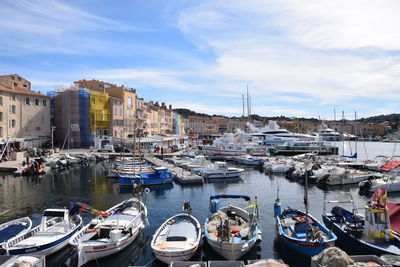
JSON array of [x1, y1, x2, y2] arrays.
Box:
[[274, 162, 337, 257]]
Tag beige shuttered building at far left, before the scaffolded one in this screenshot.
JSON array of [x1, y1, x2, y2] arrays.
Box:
[[0, 74, 50, 148]]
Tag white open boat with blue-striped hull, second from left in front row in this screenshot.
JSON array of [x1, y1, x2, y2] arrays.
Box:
[[3, 209, 82, 256]]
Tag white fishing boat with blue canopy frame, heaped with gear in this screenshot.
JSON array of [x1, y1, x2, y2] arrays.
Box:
[[204, 195, 261, 261]]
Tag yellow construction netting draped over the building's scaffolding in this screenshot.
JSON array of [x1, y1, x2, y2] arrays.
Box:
[[90, 90, 111, 135]]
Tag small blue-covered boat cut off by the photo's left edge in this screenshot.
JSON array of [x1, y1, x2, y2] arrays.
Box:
[[0, 217, 32, 246]]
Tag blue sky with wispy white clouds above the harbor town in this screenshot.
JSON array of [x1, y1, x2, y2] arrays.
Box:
[[0, 0, 400, 119]]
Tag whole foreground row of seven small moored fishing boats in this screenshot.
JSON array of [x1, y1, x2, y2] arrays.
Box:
[[0, 189, 400, 266]]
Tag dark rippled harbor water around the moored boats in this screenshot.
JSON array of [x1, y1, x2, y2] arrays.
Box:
[[0, 142, 400, 266]]
